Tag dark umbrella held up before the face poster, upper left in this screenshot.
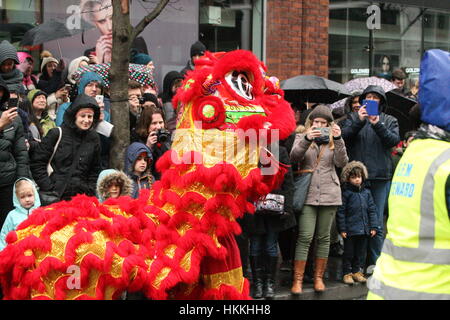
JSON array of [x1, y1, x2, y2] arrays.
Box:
[[20, 19, 93, 46]]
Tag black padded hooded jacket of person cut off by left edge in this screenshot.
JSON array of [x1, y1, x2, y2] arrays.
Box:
[[0, 77, 30, 187]]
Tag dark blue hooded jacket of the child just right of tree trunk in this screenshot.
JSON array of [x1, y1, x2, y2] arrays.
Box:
[[125, 142, 155, 199]]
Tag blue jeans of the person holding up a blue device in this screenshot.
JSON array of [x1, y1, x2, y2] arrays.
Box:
[[363, 180, 391, 266]]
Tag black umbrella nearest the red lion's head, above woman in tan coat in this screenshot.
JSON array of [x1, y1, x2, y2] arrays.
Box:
[[281, 75, 350, 105]]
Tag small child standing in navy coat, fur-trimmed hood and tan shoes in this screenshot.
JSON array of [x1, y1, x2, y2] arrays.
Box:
[[336, 161, 379, 284]]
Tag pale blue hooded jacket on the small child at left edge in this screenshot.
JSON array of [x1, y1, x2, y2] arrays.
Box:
[[0, 178, 41, 251]]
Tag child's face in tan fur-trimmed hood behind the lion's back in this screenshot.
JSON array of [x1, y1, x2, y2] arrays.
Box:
[[97, 169, 133, 202]]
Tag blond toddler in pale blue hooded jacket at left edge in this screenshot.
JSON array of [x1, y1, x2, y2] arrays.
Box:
[[0, 178, 41, 251]]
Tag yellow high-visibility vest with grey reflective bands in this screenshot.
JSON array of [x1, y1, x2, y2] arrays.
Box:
[[367, 139, 450, 300]]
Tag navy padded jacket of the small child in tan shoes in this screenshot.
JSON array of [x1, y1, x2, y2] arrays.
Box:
[[336, 183, 379, 237]]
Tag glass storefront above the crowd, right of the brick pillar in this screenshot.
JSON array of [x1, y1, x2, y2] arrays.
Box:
[[329, 0, 450, 86]]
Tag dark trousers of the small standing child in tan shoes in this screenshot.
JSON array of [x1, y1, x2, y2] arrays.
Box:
[[342, 235, 369, 275]]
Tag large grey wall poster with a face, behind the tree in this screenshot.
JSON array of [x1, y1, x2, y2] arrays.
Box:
[[32, 0, 199, 87]]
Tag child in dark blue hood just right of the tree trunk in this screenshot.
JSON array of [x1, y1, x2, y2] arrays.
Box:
[[125, 142, 155, 199]]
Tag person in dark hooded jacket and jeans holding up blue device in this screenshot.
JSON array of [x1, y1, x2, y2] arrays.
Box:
[[342, 86, 400, 273]]
